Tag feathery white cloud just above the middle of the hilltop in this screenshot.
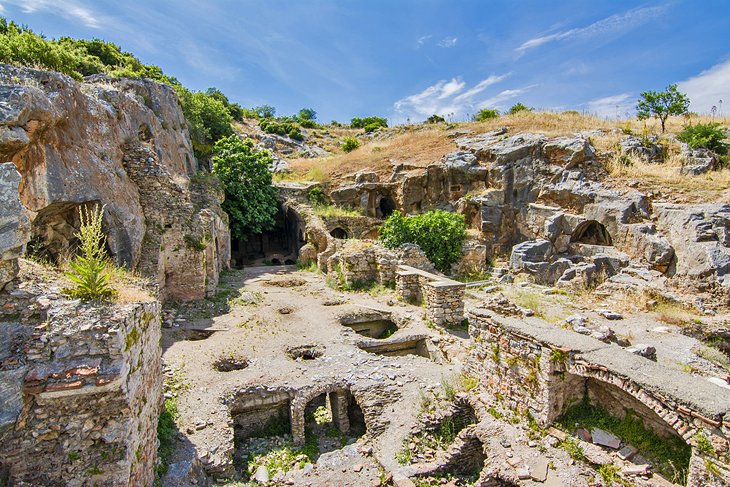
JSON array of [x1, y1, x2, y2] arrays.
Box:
[[393, 73, 516, 118]]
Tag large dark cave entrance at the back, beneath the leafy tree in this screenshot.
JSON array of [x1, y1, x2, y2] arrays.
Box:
[[231, 207, 306, 267]]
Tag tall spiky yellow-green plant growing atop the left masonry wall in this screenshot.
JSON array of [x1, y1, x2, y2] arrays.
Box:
[[66, 206, 116, 301]]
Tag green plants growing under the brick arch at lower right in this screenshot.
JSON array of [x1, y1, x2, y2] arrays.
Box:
[[558, 399, 691, 485]]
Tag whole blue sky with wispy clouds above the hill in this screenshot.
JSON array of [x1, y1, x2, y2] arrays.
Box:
[[0, 0, 730, 123]]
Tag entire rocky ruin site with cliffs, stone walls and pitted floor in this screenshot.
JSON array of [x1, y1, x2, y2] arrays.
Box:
[[0, 25, 730, 487]]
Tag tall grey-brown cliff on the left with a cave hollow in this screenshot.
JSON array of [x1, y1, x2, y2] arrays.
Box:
[[0, 65, 230, 299]]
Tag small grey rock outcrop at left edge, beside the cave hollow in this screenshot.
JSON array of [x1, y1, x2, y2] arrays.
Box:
[[0, 163, 30, 291]]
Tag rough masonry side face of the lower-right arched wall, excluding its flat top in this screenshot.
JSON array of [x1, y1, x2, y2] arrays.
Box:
[[466, 310, 730, 486]]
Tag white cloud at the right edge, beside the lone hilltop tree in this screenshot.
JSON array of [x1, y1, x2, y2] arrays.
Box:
[[678, 59, 730, 115]]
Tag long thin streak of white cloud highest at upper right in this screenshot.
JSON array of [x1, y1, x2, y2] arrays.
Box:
[[515, 5, 667, 54]]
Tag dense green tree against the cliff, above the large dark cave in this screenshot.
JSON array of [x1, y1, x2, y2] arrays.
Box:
[[213, 135, 277, 240]]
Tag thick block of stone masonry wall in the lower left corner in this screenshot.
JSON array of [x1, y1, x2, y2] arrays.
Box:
[[0, 298, 162, 486]]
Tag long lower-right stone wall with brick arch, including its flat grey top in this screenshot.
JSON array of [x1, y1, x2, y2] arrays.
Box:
[[467, 309, 730, 486]]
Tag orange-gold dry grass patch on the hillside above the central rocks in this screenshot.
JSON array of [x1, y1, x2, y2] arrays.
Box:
[[285, 128, 456, 181]]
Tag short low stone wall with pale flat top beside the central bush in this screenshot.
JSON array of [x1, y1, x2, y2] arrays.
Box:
[[395, 265, 466, 326]]
